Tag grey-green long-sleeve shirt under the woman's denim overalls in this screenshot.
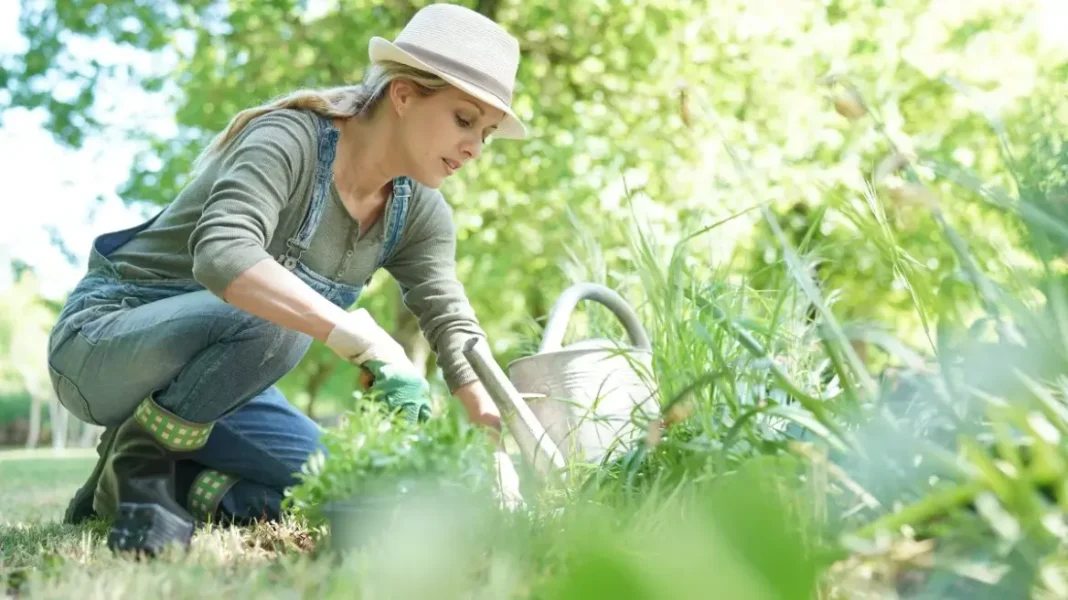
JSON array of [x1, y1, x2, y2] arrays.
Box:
[[109, 109, 485, 391]]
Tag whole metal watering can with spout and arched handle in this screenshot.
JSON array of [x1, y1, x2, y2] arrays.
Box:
[[465, 283, 659, 475]]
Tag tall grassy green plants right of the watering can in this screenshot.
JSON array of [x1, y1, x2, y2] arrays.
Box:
[[559, 68, 1068, 597]]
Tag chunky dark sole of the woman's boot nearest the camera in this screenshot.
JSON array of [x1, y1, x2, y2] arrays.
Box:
[[108, 503, 193, 556]]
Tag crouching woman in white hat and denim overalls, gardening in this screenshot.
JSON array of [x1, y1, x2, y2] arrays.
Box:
[[49, 4, 525, 554]]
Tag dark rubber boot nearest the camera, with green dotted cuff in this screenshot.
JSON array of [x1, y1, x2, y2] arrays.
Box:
[[93, 397, 211, 556]]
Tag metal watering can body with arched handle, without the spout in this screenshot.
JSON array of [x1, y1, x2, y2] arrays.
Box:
[[508, 283, 659, 462]]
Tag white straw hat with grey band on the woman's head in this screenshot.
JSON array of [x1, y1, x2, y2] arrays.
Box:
[[370, 4, 527, 140]]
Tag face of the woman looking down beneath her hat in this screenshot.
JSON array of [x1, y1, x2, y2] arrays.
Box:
[[390, 81, 504, 188]]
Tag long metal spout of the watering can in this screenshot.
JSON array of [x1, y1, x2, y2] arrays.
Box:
[[464, 337, 565, 477]]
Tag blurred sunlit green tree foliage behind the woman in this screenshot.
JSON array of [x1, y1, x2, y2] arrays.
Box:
[[0, 0, 1068, 416]]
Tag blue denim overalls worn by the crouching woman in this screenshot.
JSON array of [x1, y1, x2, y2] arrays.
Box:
[[48, 117, 412, 518]]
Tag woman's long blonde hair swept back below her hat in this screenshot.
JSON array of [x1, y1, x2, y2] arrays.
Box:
[[194, 61, 450, 170]]
